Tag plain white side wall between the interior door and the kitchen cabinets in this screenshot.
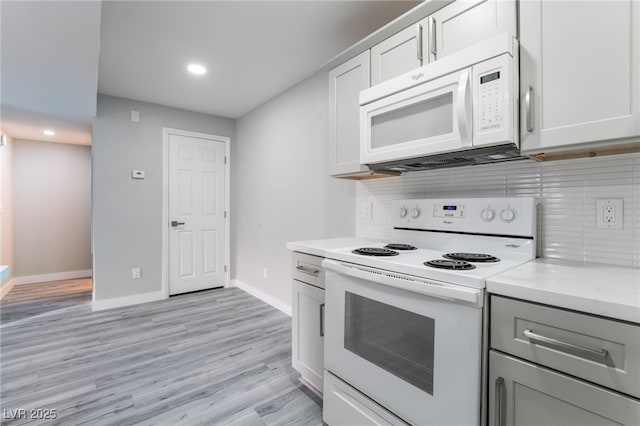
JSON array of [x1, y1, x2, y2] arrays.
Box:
[[232, 72, 355, 306]]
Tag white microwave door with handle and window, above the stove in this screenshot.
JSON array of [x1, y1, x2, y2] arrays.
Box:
[[360, 68, 473, 164]]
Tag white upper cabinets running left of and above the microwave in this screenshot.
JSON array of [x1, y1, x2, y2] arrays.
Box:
[[329, 0, 530, 178]]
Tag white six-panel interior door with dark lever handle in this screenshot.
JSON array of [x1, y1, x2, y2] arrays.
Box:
[[168, 134, 226, 295]]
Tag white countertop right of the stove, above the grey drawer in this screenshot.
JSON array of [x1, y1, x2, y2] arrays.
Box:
[[487, 259, 640, 324]]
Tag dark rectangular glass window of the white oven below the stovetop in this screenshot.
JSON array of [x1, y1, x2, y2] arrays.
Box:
[[344, 292, 435, 395]]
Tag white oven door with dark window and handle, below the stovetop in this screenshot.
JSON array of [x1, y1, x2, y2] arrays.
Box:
[[323, 260, 483, 425]]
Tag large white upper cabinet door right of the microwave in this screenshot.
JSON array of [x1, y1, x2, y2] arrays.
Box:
[[520, 0, 640, 154]]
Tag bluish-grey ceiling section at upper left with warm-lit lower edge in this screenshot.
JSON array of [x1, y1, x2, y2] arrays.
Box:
[[0, 0, 101, 143]]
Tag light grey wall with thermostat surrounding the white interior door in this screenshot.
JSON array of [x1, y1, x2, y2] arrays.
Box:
[[92, 95, 235, 304]]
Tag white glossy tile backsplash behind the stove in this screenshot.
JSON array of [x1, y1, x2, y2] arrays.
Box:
[[356, 153, 640, 268]]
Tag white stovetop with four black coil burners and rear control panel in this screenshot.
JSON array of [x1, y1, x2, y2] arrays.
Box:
[[326, 197, 537, 289]]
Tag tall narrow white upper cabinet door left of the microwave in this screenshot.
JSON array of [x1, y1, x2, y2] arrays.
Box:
[[329, 50, 370, 176]]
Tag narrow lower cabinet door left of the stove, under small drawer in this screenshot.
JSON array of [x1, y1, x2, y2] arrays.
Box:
[[291, 280, 324, 392]]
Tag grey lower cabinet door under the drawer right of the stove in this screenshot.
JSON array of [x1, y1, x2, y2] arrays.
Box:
[[489, 350, 640, 426]]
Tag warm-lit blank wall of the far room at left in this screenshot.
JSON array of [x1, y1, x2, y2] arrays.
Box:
[[13, 140, 91, 281]]
